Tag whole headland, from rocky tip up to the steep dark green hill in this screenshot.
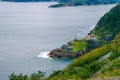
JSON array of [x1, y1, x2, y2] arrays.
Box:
[[48, 3, 120, 58]]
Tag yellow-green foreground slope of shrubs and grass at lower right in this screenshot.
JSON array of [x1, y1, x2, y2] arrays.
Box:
[[47, 32, 120, 80]]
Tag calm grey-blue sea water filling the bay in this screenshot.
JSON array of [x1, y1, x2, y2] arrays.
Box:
[[0, 2, 115, 80]]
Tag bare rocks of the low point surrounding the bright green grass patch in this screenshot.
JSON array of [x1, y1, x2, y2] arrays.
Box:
[[48, 34, 108, 59]]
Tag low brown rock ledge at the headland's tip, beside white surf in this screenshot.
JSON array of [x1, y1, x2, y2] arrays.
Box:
[[48, 48, 84, 59]]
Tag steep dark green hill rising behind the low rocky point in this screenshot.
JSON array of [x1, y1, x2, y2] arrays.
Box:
[[91, 4, 120, 40]]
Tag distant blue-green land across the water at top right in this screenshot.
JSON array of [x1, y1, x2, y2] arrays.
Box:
[[49, 0, 120, 8]]
